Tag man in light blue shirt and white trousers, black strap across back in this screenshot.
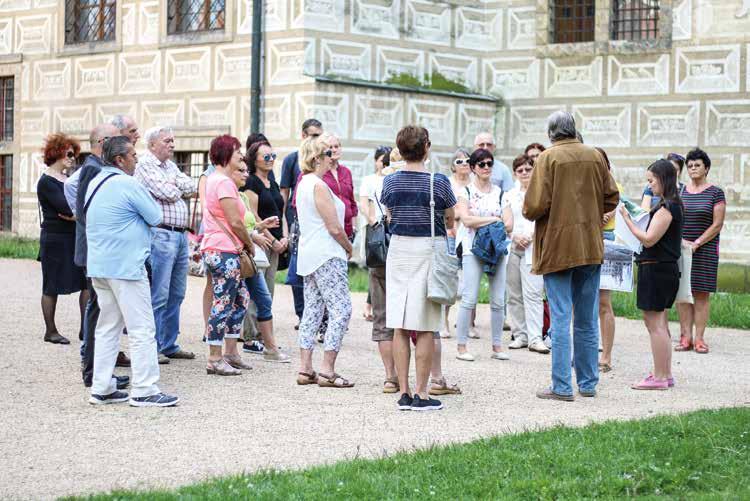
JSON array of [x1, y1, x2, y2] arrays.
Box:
[[83, 136, 179, 407]]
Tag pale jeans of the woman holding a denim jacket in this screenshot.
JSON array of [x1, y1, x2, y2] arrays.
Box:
[[456, 254, 508, 346]]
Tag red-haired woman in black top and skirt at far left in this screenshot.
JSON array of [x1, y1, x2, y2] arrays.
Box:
[[36, 134, 89, 344]]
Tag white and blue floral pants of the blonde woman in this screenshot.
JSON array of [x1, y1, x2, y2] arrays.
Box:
[[299, 258, 352, 352]]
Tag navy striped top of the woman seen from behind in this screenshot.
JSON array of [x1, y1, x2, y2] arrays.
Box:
[[380, 170, 456, 237]]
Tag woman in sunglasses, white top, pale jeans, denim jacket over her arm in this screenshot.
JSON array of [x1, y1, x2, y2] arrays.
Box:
[[456, 148, 513, 362]]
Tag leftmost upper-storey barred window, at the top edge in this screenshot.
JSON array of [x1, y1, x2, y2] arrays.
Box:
[[65, 0, 117, 44]]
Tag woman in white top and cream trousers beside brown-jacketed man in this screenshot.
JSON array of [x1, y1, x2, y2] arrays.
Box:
[[503, 154, 549, 353]]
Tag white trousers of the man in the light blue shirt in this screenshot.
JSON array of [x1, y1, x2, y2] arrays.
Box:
[[91, 278, 159, 397]]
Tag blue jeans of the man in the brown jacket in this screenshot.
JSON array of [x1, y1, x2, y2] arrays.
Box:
[[544, 264, 601, 396]]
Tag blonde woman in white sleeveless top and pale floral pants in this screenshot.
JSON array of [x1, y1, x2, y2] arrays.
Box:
[[296, 135, 354, 388]]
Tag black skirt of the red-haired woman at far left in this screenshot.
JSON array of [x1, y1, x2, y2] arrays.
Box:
[[39, 230, 86, 296]]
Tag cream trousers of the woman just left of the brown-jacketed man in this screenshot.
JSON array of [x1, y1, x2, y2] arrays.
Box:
[[508, 251, 544, 344]]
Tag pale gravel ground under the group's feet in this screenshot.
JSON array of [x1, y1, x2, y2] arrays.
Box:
[[0, 260, 750, 499]]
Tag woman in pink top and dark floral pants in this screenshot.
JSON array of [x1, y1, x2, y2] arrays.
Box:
[[201, 135, 255, 376]]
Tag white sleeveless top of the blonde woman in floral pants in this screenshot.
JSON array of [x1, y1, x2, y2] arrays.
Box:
[[296, 174, 346, 277]]
